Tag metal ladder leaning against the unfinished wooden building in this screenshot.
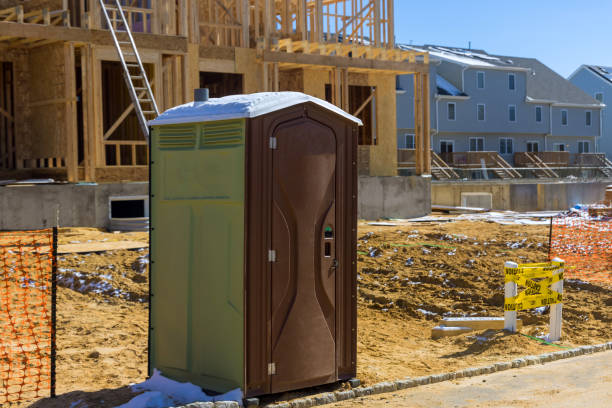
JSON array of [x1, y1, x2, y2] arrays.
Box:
[[99, 0, 159, 142]]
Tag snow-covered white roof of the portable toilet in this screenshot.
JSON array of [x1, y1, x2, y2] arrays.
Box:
[[149, 92, 363, 126]]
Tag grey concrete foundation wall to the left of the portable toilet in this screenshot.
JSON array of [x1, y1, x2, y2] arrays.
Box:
[[0, 183, 149, 230]]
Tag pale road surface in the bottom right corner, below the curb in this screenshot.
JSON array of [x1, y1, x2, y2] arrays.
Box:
[[329, 351, 612, 408]]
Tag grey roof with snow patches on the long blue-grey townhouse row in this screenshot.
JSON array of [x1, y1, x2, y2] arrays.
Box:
[[404, 45, 612, 107]]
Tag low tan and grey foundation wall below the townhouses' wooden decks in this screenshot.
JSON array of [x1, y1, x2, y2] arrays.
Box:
[[431, 179, 612, 211]]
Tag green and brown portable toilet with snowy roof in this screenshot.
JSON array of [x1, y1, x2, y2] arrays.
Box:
[[149, 92, 361, 397]]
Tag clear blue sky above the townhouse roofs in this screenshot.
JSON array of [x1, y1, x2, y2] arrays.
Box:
[[394, 0, 612, 77]]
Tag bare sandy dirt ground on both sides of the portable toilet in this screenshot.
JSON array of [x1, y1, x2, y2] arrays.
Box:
[[28, 219, 612, 407]]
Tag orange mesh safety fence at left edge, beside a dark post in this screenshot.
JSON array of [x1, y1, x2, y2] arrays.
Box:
[[0, 228, 57, 407]]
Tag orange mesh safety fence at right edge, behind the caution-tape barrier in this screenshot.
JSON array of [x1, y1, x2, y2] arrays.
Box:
[[549, 216, 612, 286]]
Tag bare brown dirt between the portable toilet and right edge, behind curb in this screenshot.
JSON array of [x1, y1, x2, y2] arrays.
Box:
[[357, 221, 612, 383]]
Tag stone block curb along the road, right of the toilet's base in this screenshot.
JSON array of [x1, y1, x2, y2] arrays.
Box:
[[260, 341, 612, 408]]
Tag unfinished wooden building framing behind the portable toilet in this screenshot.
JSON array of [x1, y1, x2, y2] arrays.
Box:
[[0, 0, 430, 182]]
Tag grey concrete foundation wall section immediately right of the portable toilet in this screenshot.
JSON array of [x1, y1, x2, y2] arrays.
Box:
[[358, 176, 431, 220]]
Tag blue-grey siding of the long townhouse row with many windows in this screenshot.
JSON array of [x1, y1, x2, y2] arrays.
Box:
[[397, 61, 612, 156]]
